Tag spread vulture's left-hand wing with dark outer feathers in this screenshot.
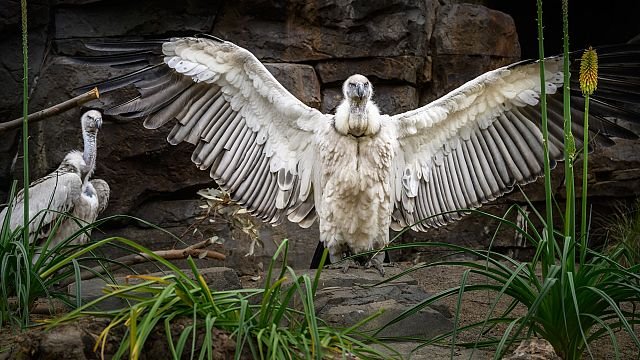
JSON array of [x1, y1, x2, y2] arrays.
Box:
[[82, 37, 330, 227]]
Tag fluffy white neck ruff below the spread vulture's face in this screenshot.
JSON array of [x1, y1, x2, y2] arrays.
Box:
[[335, 99, 380, 137]]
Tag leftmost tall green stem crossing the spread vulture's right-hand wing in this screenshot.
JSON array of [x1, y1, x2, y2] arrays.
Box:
[[537, 0, 555, 277]]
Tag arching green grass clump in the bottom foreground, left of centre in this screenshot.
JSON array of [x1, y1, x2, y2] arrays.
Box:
[[51, 240, 393, 359]]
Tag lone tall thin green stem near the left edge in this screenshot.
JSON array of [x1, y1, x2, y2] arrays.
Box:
[[20, 0, 29, 245]]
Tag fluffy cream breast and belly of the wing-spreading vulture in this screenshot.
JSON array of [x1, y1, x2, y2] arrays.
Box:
[[316, 117, 395, 253]]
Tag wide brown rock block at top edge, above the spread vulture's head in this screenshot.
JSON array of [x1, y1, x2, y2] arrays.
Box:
[[215, 0, 437, 62]]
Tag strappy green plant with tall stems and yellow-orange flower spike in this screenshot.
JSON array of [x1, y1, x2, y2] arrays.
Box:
[[376, 0, 640, 360]]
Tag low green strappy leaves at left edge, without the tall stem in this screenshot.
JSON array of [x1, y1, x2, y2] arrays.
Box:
[[0, 211, 142, 327]]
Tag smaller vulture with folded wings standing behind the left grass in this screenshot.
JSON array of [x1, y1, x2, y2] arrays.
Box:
[[0, 110, 109, 253]]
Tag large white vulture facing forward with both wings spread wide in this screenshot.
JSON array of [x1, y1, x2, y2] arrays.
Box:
[[77, 36, 640, 274]]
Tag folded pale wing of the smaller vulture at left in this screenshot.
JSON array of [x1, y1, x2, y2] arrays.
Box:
[[0, 167, 82, 242]]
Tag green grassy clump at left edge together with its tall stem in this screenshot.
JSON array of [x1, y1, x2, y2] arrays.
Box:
[[0, 0, 110, 327]]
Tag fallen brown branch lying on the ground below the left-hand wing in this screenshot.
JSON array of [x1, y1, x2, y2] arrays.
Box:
[[60, 239, 226, 287]]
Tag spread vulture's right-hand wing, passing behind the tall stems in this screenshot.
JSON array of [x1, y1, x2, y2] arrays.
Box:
[[392, 45, 640, 231]]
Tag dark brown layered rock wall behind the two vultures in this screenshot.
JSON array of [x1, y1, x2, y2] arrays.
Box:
[[0, 0, 640, 272]]
